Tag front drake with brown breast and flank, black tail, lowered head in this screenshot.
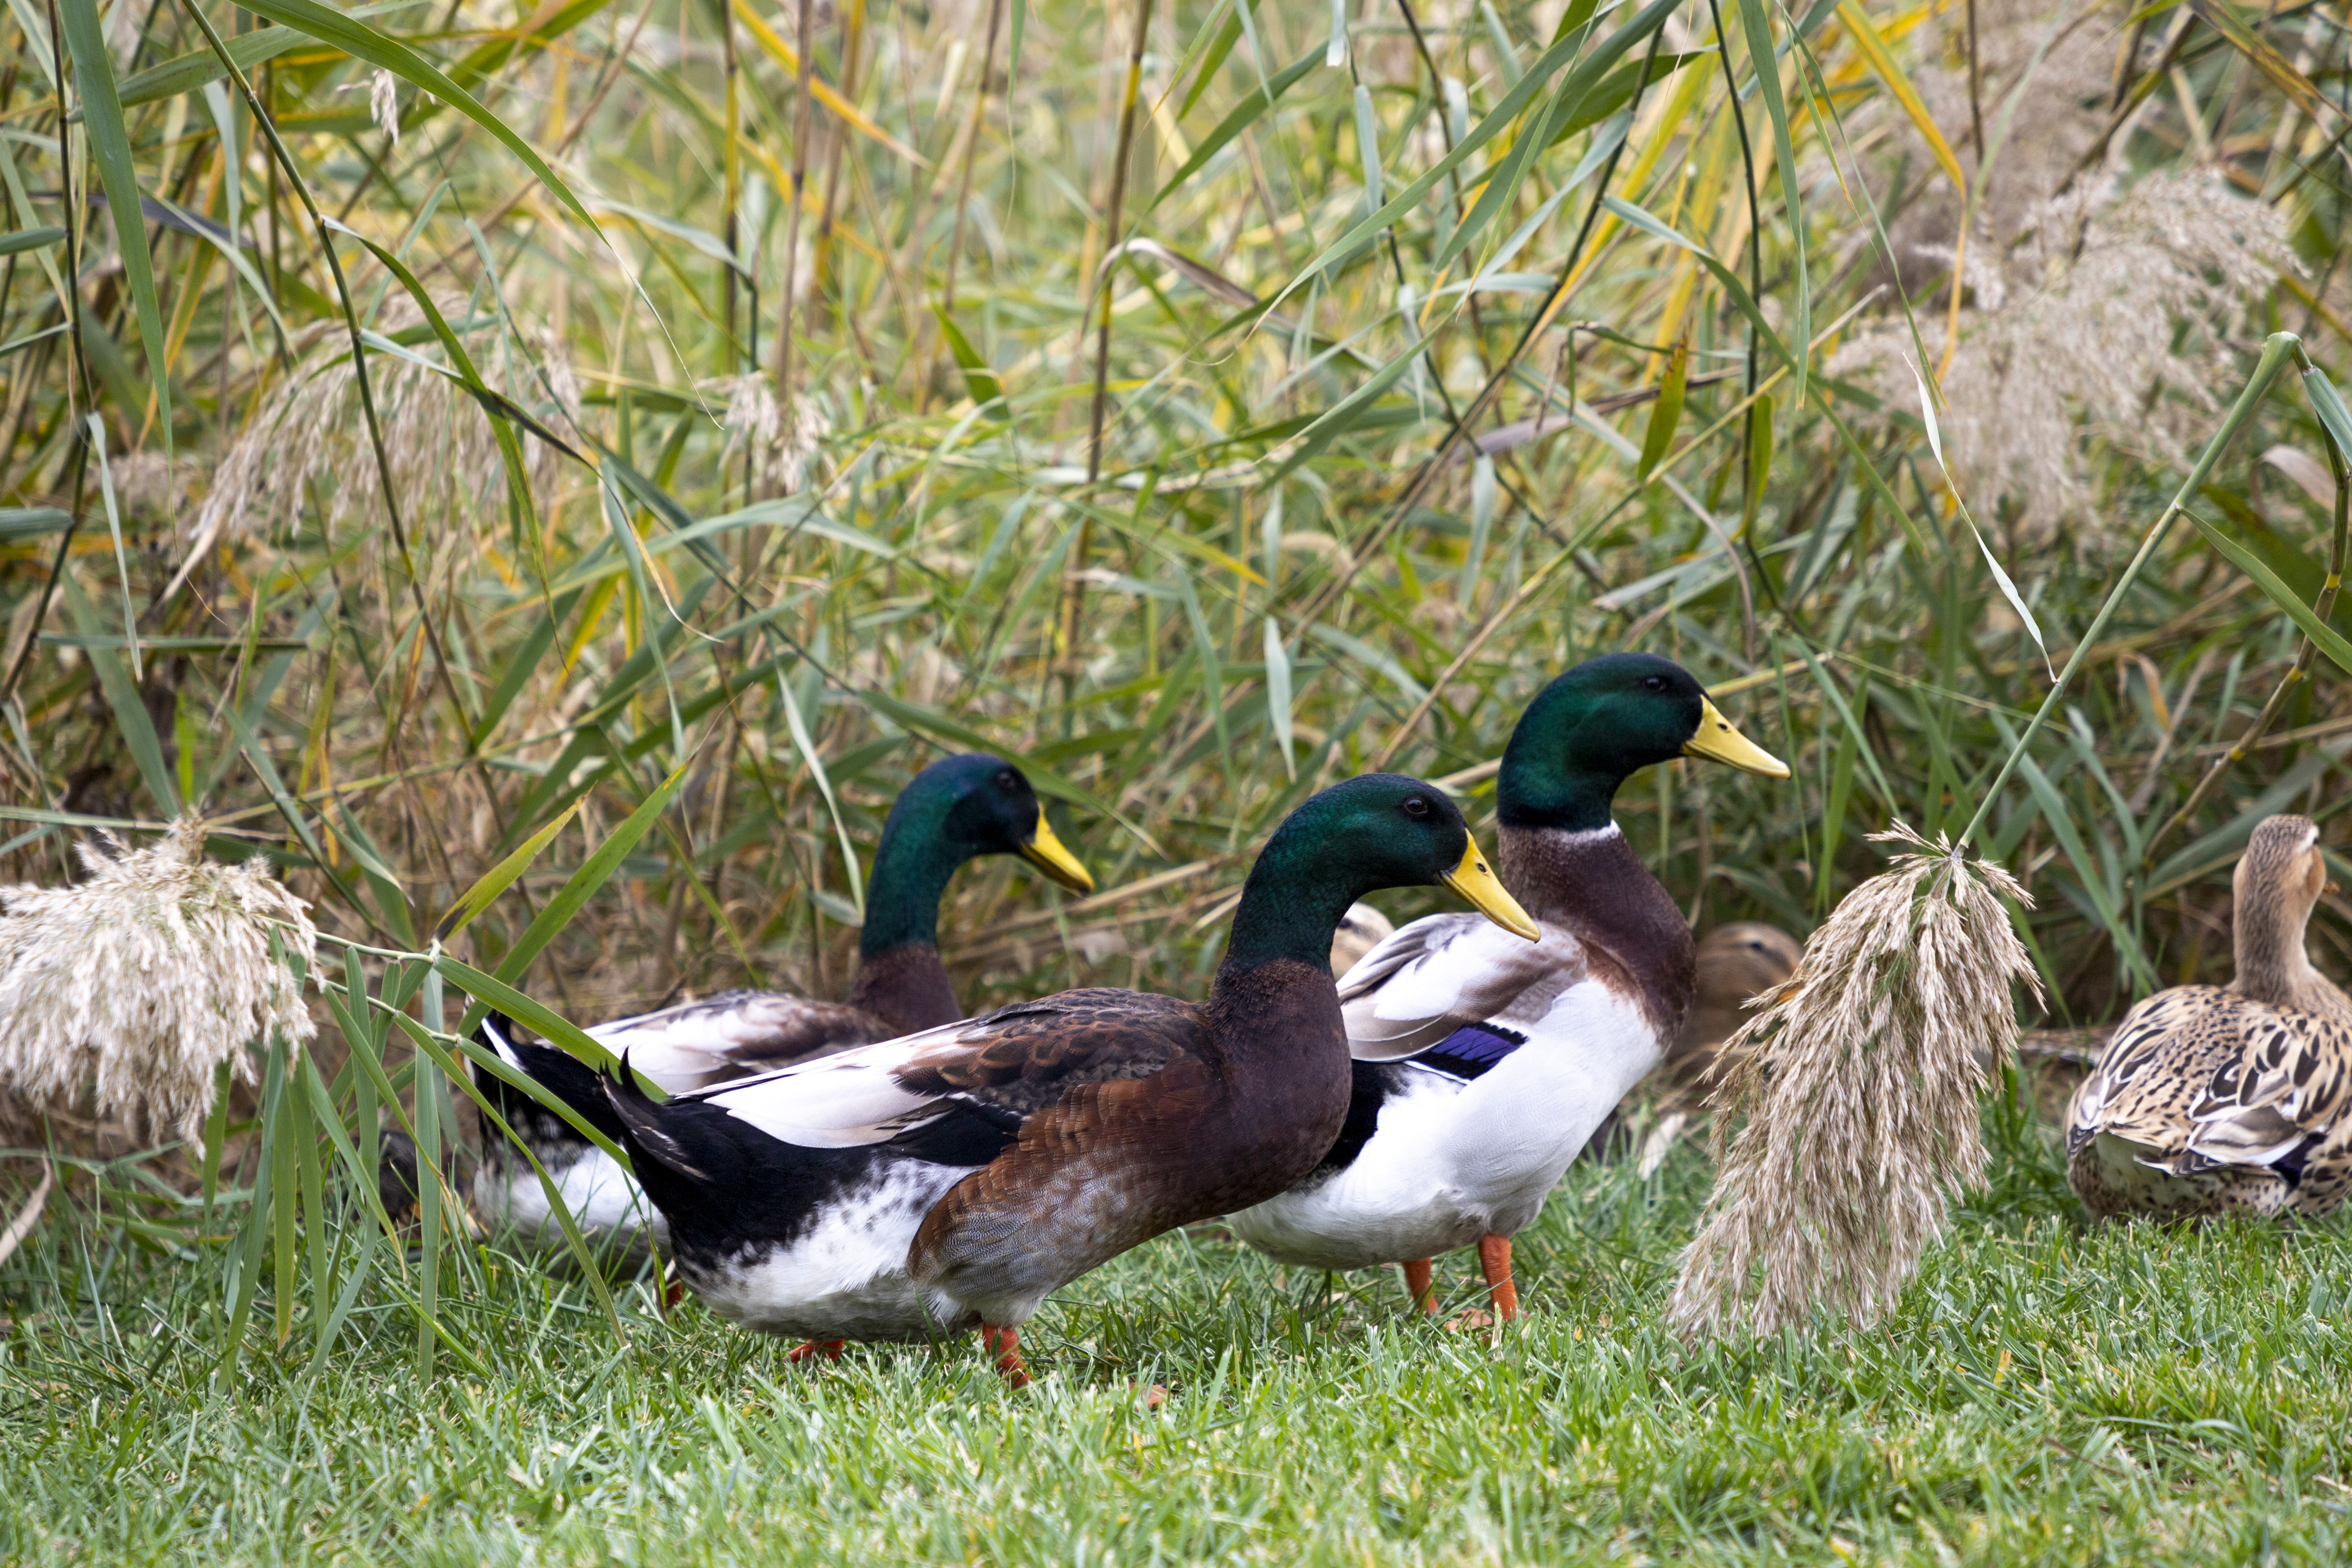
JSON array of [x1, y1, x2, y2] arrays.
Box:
[[607, 773, 1536, 1384]]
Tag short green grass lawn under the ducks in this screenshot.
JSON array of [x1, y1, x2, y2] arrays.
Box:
[[0, 1105, 2352, 1566]]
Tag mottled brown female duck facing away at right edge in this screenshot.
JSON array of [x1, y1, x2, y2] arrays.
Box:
[[2065, 816, 2352, 1220]]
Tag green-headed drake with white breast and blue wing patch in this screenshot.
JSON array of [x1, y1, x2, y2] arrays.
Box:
[[1228, 653, 1787, 1316]]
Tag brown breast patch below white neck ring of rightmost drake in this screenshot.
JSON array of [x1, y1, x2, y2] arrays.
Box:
[[1496, 823, 1698, 1035]]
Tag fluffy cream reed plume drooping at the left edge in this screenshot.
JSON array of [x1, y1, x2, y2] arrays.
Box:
[[0, 816, 318, 1138]]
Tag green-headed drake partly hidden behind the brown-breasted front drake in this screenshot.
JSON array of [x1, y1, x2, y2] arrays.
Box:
[[473, 754, 1094, 1248]]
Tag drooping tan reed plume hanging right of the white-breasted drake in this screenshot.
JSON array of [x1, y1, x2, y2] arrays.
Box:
[[1667, 820, 2039, 1340]]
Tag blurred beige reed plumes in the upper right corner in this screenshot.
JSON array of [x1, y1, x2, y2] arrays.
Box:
[[1832, 0, 2302, 545]]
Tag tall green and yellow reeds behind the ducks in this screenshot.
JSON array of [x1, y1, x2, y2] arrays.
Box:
[[0, 0, 2352, 1554]]
